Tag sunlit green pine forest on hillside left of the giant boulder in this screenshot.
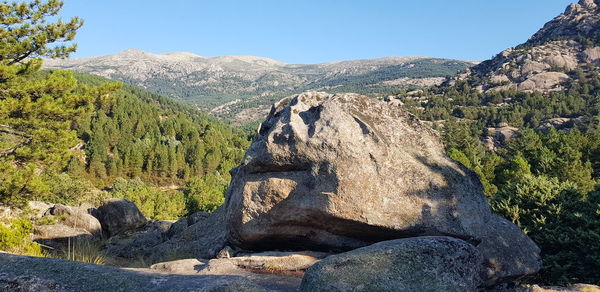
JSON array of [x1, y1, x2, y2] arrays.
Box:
[[0, 71, 249, 219]]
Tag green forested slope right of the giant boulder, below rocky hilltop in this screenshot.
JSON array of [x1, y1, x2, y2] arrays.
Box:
[[398, 71, 600, 284]]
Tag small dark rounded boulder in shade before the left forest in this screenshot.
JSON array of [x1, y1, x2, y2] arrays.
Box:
[[95, 199, 147, 236]]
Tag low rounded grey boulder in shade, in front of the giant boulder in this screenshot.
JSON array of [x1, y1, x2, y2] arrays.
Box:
[[300, 237, 482, 292]]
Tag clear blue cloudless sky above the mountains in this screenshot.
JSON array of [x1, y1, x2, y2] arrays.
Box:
[[62, 0, 576, 63]]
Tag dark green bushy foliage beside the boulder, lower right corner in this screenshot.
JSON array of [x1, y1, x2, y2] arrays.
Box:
[[490, 175, 600, 284]]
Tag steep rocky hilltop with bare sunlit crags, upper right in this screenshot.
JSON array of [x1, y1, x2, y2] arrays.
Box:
[[459, 0, 600, 92]]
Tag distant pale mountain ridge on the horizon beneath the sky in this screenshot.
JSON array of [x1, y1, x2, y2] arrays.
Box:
[[44, 49, 475, 124]]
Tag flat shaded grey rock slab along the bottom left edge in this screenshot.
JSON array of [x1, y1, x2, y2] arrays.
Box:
[[0, 253, 267, 292]]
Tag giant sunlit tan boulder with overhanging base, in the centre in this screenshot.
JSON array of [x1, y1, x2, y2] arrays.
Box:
[[222, 92, 540, 282]]
